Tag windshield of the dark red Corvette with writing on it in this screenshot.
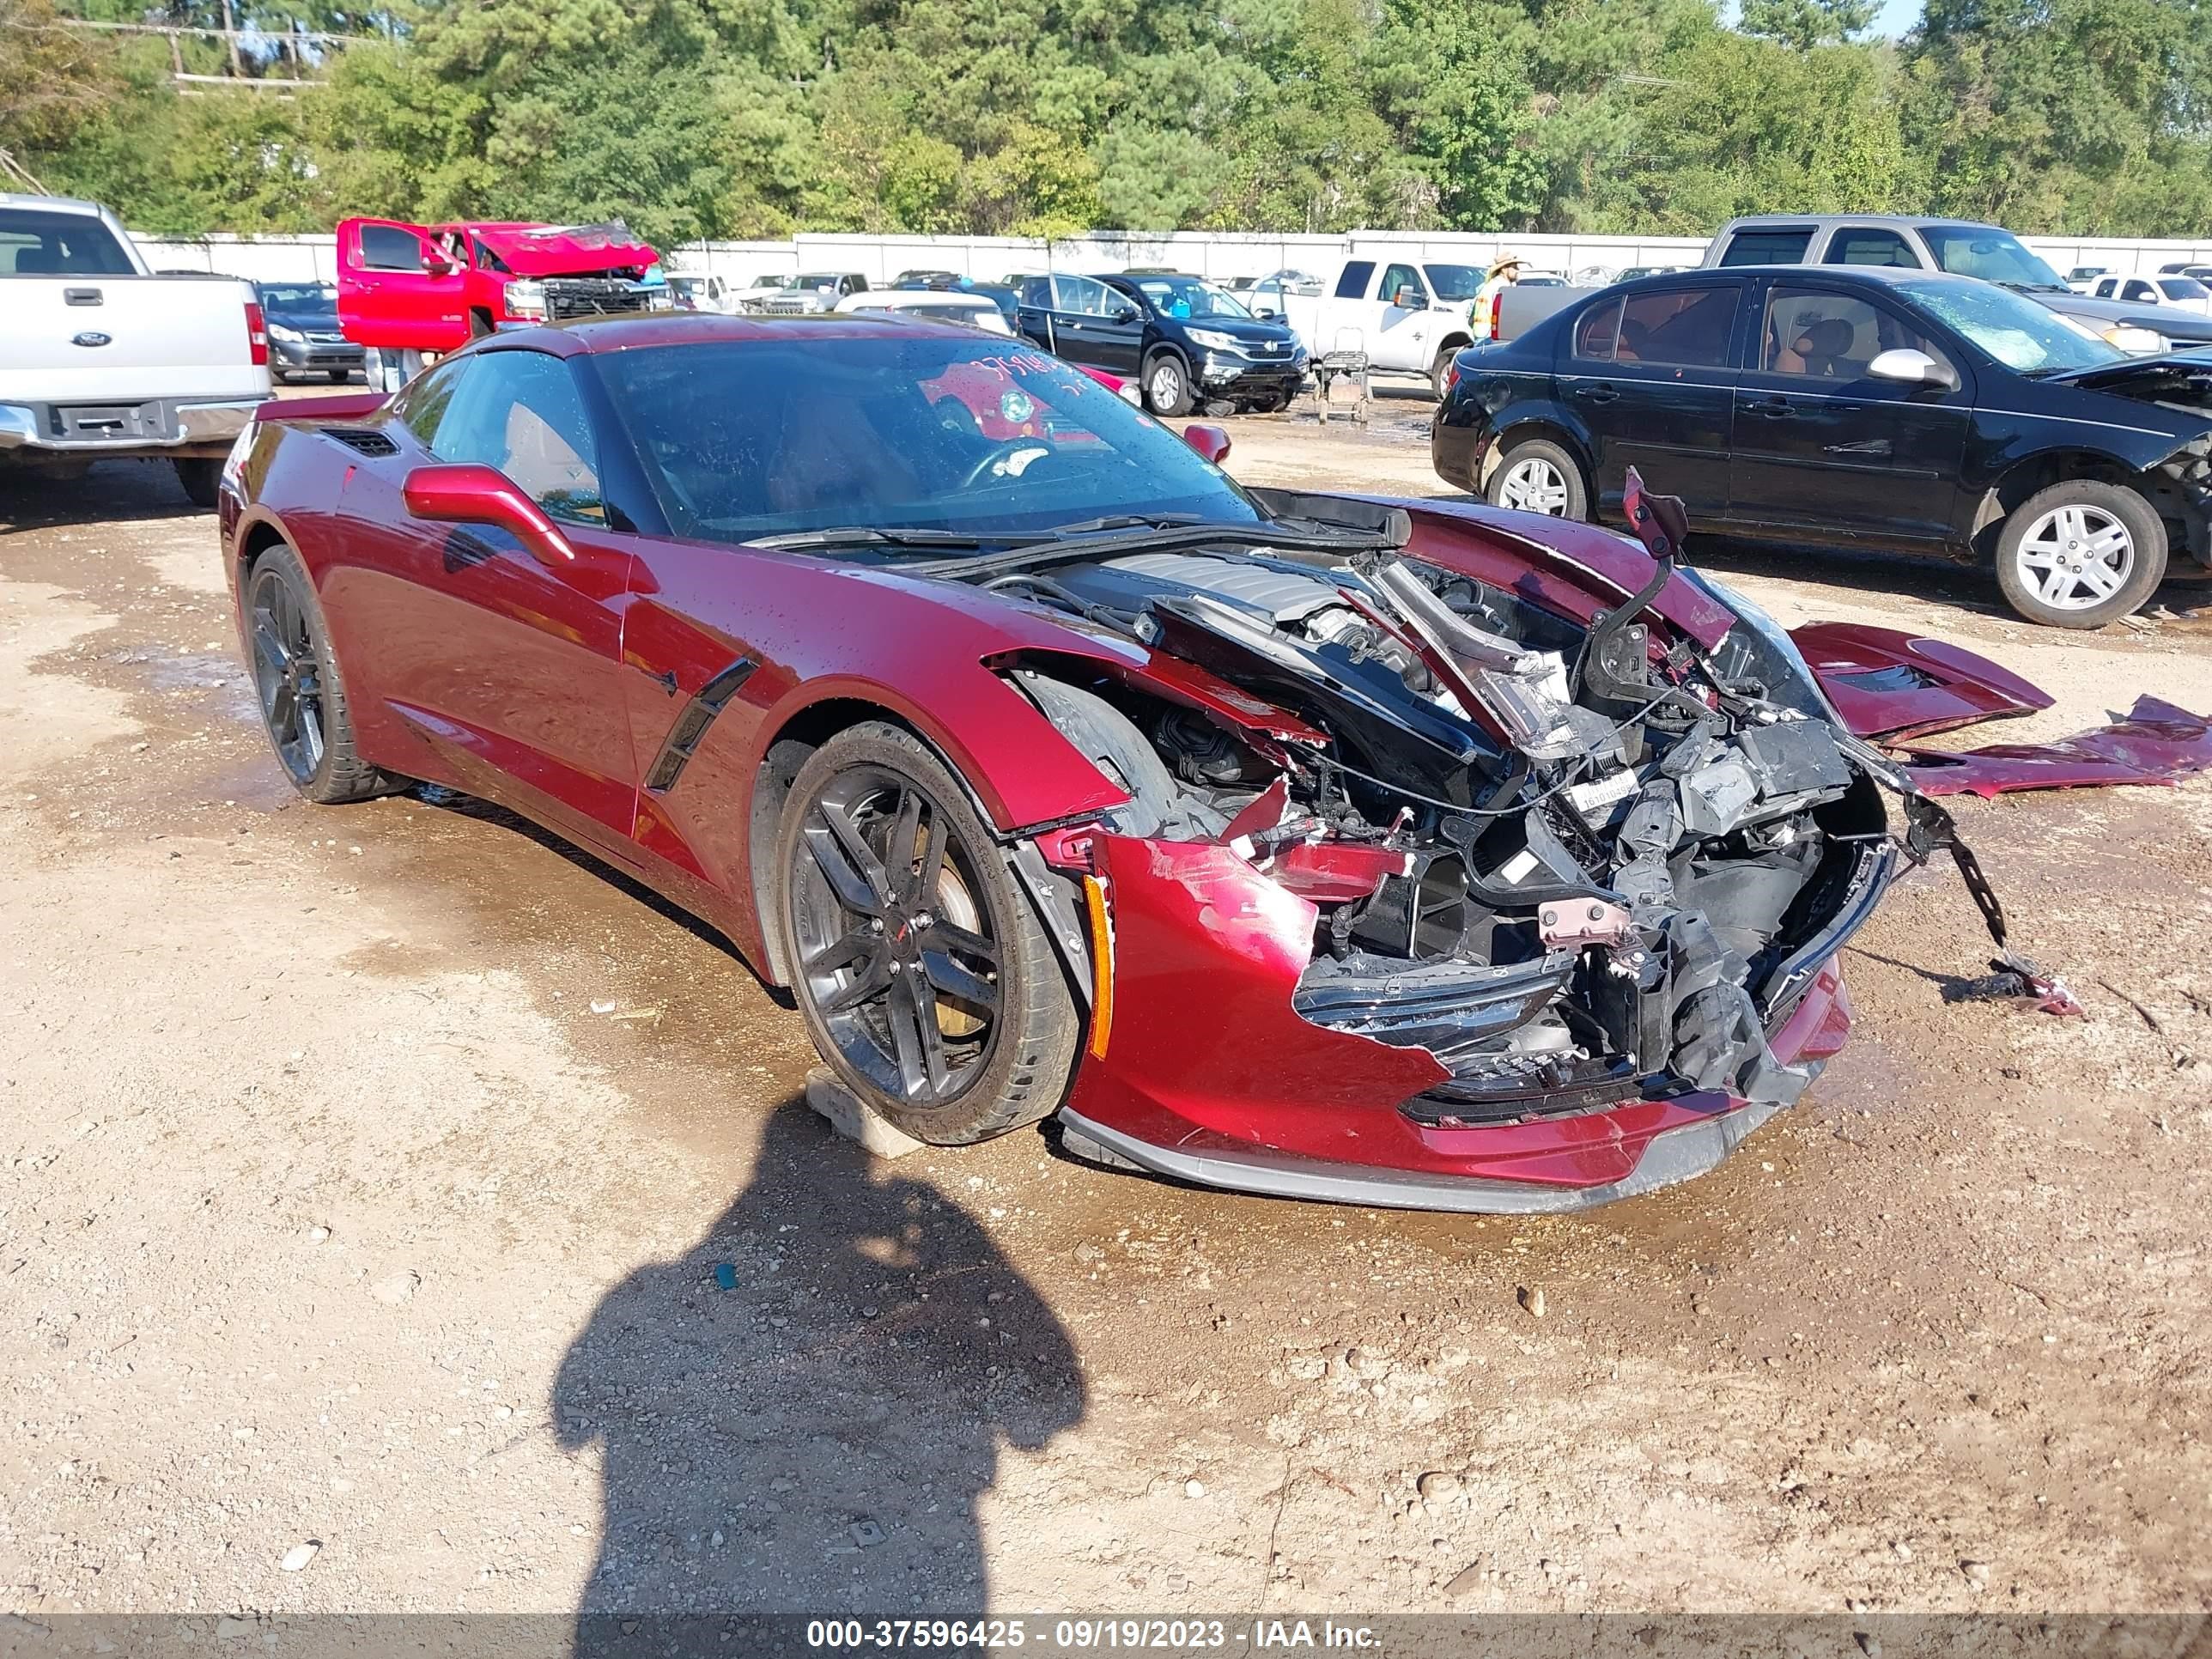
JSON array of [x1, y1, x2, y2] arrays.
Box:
[[588, 330, 1261, 556]]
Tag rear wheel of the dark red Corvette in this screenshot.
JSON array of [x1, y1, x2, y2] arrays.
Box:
[[246, 546, 407, 805]]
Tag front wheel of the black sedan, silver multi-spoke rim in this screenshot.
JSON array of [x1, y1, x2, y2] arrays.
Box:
[[1997, 477, 2167, 629]]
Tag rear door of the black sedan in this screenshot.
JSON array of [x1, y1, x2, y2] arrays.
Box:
[[1558, 279, 1743, 525]]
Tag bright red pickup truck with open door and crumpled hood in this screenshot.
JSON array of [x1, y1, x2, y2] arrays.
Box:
[[338, 219, 668, 352]]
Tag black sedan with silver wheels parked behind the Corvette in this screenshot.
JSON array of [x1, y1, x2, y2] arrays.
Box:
[[1431, 268, 2212, 629]]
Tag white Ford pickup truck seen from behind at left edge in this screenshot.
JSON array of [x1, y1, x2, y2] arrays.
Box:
[[0, 195, 270, 507]]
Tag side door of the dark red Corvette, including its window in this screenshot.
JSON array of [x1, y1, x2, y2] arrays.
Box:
[[343, 347, 637, 856]]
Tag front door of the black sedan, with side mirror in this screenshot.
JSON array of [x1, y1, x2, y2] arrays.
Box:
[[1728, 281, 1973, 546]]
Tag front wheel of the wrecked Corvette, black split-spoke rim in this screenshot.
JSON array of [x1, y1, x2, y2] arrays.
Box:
[[776, 721, 1082, 1146]]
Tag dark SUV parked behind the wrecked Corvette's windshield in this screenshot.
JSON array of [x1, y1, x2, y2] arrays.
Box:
[[1020, 270, 1305, 416]]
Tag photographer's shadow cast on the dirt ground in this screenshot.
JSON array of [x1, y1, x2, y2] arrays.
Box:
[[553, 1099, 1084, 1627]]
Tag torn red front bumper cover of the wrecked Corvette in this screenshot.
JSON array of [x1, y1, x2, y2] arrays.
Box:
[[1060, 836, 1867, 1214]]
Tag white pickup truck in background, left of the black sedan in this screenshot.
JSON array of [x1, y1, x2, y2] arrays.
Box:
[[1245, 258, 1482, 398]]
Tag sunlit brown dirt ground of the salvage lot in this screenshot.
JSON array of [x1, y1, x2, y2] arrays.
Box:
[[0, 400, 2212, 1614]]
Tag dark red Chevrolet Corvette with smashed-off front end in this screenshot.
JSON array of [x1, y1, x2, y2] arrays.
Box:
[[222, 314, 2033, 1210]]
